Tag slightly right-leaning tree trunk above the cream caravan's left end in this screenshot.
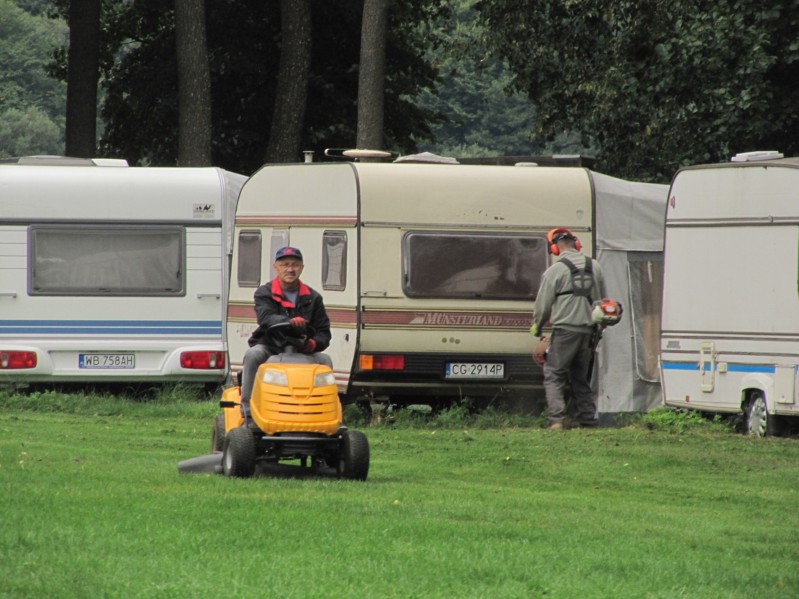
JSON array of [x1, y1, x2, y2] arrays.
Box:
[[266, 0, 311, 162]]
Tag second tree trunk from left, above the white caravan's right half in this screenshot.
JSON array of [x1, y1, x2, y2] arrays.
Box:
[[175, 0, 211, 166]]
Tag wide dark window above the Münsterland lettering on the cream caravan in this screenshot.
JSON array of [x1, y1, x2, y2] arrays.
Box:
[[402, 231, 547, 300]]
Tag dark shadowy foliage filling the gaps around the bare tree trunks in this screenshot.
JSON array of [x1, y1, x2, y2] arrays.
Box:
[[60, 0, 446, 173]]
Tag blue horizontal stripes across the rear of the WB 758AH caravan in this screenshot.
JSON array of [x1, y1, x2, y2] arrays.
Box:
[[0, 320, 222, 335]]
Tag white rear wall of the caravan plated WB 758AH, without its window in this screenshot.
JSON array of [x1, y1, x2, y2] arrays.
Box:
[[0, 165, 244, 384]]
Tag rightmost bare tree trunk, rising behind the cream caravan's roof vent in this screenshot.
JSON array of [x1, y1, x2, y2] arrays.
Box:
[[356, 0, 391, 150]]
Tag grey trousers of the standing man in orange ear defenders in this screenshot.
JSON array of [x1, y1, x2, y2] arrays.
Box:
[[544, 329, 597, 426]]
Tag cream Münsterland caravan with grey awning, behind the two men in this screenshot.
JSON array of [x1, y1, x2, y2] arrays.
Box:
[[228, 157, 667, 412]]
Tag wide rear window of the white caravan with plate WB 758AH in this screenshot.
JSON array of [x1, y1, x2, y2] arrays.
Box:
[[28, 225, 186, 296]]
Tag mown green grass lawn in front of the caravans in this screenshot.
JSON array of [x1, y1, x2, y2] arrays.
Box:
[[0, 393, 799, 599]]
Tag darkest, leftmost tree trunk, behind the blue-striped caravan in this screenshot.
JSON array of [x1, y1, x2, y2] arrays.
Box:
[[64, 0, 101, 158]]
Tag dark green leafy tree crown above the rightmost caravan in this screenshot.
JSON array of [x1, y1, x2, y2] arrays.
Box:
[[479, 0, 799, 181]]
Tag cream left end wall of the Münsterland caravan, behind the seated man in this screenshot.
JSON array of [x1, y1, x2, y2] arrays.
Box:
[[227, 163, 359, 393]]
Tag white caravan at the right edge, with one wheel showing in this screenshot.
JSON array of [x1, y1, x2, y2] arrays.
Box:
[[660, 152, 799, 436]]
